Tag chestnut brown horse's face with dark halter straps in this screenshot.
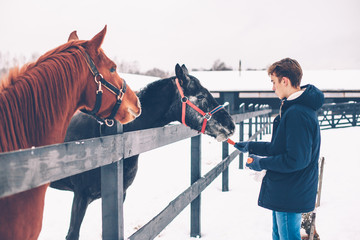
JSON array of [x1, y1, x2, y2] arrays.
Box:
[[75, 26, 141, 124]]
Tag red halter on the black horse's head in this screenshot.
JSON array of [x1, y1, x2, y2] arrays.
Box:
[[175, 78, 224, 133]]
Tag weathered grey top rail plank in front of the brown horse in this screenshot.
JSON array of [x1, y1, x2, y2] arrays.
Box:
[[0, 136, 123, 197]]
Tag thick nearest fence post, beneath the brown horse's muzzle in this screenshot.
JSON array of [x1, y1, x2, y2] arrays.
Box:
[[101, 122, 124, 240]]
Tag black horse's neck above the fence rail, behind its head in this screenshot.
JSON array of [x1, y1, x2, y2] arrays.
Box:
[[124, 78, 181, 132]]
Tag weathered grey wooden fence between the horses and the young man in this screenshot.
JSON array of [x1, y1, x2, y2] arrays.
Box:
[[0, 106, 271, 240]]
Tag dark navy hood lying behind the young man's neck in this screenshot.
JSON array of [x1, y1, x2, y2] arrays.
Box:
[[282, 84, 324, 111]]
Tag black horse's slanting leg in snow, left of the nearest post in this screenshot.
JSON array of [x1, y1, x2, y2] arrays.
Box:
[[66, 192, 92, 240]]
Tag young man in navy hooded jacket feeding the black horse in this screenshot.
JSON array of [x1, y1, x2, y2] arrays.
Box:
[[235, 58, 324, 240]]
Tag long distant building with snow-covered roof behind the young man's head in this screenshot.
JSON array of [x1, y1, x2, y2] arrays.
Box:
[[190, 70, 360, 111]]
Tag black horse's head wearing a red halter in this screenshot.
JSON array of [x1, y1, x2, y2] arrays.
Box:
[[175, 64, 235, 141]]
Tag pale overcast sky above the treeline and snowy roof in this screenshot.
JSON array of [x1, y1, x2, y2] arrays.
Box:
[[0, 0, 360, 71]]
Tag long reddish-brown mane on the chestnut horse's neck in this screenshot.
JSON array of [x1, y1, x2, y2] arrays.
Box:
[[0, 41, 87, 152]]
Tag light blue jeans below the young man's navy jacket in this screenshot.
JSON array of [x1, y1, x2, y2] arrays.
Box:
[[272, 211, 301, 240]]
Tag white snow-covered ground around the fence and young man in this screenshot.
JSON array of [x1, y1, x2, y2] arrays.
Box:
[[39, 127, 360, 240]]
